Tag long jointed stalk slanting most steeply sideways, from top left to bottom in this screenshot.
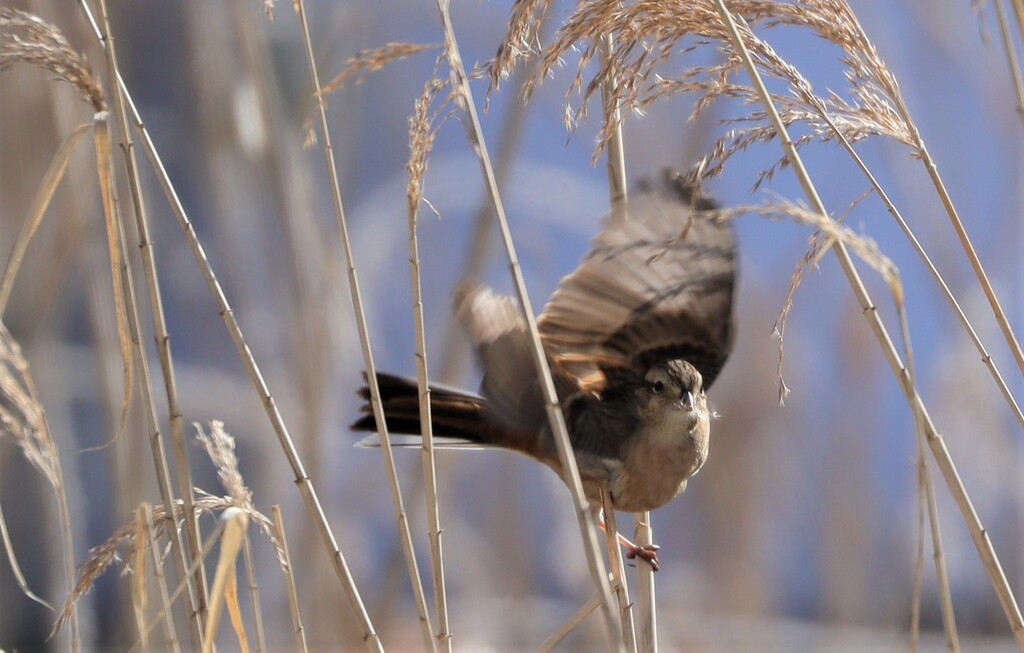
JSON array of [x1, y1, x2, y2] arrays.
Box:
[[76, 3, 383, 650]]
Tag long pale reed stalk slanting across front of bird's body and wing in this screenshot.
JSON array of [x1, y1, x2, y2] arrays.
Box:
[[434, 0, 623, 650]]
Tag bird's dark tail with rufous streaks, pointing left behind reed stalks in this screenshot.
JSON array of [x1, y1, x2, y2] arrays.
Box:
[[351, 373, 519, 448]]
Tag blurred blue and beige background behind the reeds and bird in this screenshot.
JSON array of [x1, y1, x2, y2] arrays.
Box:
[[0, 0, 1024, 651]]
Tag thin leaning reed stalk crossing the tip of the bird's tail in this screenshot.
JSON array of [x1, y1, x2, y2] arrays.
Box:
[[295, 0, 436, 651]]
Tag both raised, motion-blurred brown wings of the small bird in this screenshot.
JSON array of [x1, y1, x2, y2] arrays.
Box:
[[456, 174, 735, 440]]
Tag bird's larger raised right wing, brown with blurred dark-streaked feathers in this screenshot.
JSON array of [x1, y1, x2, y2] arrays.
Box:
[[539, 172, 736, 388]]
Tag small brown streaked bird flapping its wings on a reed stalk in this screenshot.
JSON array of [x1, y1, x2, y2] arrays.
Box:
[[352, 170, 737, 569]]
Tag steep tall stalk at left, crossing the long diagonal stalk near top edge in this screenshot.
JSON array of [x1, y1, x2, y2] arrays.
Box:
[[92, 0, 207, 627]]
